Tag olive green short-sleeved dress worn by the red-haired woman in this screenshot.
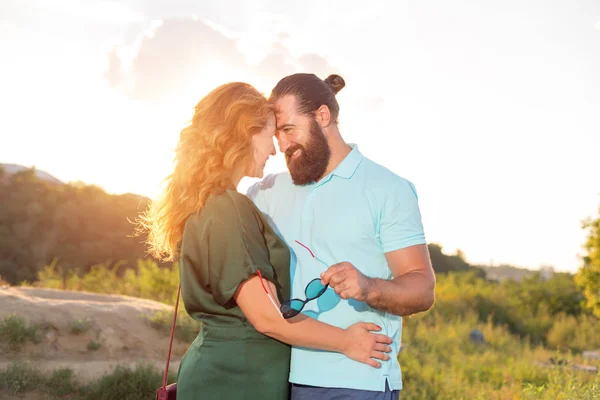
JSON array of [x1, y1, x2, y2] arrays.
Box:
[[177, 190, 290, 400]]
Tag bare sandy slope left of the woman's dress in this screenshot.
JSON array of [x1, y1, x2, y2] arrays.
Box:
[[0, 287, 187, 380]]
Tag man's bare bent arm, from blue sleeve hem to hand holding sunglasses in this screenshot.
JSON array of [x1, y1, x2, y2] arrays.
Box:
[[321, 244, 435, 316]]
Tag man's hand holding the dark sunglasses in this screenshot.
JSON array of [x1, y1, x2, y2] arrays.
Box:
[[321, 261, 371, 301]]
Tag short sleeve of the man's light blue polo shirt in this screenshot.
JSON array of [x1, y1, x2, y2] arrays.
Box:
[[379, 178, 426, 253]]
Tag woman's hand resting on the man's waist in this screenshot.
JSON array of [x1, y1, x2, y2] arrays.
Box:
[[344, 322, 392, 368]]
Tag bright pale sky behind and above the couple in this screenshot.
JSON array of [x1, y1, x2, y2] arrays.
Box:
[[0, 0, 600, 272]]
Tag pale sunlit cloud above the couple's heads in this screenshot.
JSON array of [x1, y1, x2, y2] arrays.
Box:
[[105, 18, 338, 100]]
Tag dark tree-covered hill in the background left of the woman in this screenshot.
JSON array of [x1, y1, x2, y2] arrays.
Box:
[[0, 164, 161, 284]]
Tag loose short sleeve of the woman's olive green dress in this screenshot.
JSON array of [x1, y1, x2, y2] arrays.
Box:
[[182, 192, 274, 306]]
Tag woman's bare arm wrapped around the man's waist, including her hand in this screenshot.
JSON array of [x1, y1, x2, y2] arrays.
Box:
[[234, 275, 392, 368]]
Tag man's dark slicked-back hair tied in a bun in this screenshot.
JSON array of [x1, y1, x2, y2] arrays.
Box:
[[269, 74, 346, 124]]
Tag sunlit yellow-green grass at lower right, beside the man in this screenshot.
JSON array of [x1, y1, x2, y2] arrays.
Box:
[[399, 306, 600, 400]]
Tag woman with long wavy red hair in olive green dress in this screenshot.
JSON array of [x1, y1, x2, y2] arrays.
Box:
[[141, 83, 391, 400]]
